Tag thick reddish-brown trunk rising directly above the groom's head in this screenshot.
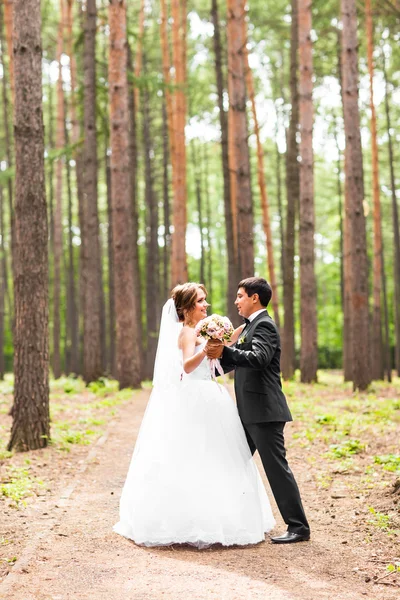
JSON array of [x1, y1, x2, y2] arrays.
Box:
[[227, 0, 254, 278]]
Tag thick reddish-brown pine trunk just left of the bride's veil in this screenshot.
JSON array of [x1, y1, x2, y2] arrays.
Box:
[[109, 0, 140, 389]]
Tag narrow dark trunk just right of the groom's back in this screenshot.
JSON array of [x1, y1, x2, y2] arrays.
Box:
[[281, 0, 300, 379]]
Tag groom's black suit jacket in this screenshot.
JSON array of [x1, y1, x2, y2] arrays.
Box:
[[221, 311, 292, 424]]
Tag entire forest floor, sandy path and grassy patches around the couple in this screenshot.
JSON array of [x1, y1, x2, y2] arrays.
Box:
[[0, 371, 400, 600]]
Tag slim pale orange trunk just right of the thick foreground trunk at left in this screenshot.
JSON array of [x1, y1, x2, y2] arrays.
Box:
[[53, 0, 65, 379]]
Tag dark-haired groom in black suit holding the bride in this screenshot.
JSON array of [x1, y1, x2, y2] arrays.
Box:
[[207, 277, 310, 544]]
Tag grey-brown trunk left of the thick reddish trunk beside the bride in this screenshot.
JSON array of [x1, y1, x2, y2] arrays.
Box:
[[82, 0, 103, 383]]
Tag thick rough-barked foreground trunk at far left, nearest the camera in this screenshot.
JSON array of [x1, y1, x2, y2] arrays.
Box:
[[8, 0, 50, 451]]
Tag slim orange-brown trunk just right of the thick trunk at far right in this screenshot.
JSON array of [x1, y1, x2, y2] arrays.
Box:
[[365, 0, 384, 379]]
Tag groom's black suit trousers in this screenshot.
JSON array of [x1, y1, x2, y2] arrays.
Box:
[[243, 422, 310, 535]]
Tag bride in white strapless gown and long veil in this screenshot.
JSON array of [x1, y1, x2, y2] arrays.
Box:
[[114, 283, 275, 548]]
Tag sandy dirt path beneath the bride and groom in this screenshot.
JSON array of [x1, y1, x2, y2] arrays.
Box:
[[0, 391, 398, 600]]
